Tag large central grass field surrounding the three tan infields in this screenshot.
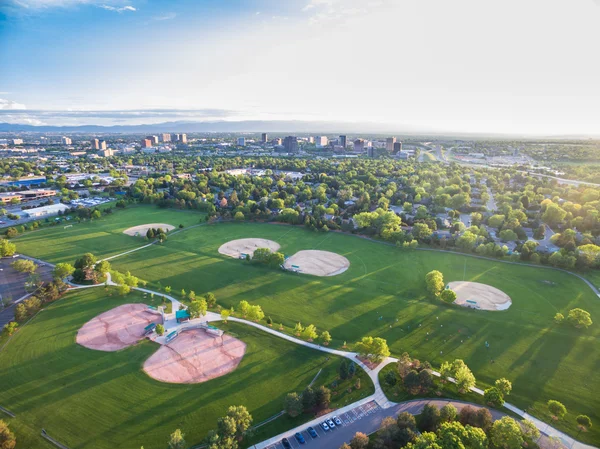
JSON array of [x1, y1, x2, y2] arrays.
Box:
[[9, 208, 600, 444]]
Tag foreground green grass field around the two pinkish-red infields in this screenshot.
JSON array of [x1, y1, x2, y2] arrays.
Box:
[[0, 287, 374, 449]]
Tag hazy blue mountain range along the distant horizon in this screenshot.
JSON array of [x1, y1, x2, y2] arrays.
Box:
[[0, 120, 600, 139]]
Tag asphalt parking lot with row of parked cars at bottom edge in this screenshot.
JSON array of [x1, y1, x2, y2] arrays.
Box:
[[267, 401, 381, 449]]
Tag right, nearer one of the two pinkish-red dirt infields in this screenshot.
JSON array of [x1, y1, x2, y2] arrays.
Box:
[[144, 329, 246, 384]]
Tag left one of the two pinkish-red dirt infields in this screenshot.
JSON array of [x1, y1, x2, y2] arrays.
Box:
[[76, 304, 162, 352]]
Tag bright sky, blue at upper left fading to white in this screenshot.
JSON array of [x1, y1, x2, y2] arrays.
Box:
[[0, 0, 600, 135]]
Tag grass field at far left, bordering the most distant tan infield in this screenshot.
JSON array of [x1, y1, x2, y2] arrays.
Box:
[[13, 206, 204, 263]]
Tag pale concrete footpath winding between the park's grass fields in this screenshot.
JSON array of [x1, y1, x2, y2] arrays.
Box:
[[14, 231, 600, 449]]
